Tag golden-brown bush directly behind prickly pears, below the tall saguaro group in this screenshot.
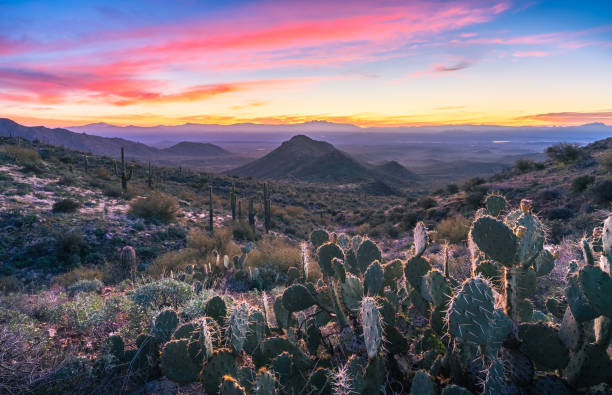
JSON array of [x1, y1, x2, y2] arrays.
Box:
[[247, 237, 302, 272]]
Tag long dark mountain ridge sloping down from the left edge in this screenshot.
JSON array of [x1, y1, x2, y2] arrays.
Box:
[[0, 118, 230, 160]]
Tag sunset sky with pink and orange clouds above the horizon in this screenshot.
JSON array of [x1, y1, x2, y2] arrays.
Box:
[[0, 0, 612, 127]]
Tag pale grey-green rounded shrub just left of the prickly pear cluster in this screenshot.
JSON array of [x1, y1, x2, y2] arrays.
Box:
[[130, 278, 193, 309]]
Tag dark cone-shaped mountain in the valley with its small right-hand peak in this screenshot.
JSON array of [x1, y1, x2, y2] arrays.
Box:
[[229, 135, 415, 184]]
